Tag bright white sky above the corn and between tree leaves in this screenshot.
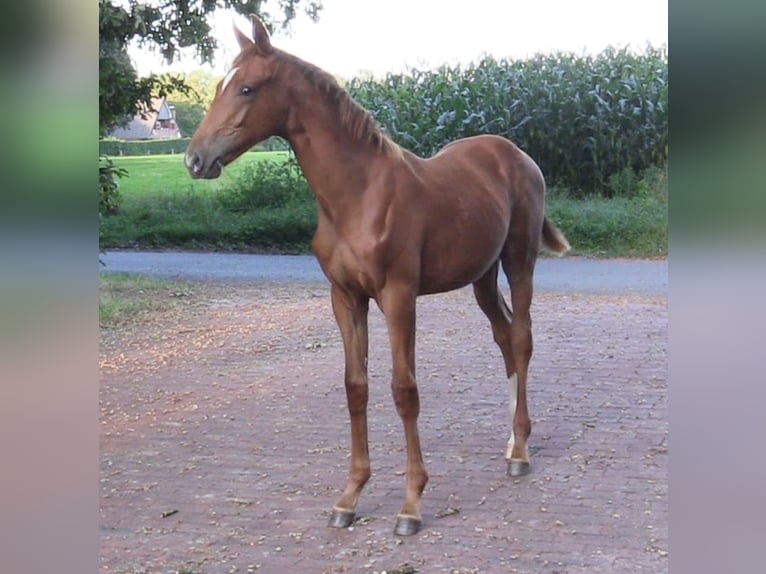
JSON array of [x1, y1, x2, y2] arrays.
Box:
[[131, 0, 668, 77]]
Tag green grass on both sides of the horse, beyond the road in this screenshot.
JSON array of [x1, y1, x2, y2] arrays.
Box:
[[102, 152, 668, 258]]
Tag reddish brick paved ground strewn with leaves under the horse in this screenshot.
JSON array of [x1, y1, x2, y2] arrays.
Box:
[[100, 284, 668, 574]]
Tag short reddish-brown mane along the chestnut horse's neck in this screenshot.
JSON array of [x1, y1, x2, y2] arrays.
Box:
[[280, 52, 402, 157]]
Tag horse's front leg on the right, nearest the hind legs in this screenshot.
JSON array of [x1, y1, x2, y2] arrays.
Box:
[[380, 289, 428, 536]]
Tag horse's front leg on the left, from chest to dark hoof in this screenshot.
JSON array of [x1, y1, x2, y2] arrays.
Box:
[[328, 285, 371, 528]]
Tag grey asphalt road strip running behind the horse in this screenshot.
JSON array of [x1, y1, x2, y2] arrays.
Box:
[[99, 251, 668, 295]]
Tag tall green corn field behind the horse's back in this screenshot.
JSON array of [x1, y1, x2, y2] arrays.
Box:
[[346, 47, 668, 196]]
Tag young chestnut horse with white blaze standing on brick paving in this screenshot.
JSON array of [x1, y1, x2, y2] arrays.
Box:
[[184, 15, 570, 536]]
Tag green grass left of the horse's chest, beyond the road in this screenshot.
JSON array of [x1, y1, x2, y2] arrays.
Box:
[[102, 152, 316, 253]]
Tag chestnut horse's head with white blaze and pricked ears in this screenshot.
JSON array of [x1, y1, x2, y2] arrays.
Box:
[[185, 15, 287, 179]]
